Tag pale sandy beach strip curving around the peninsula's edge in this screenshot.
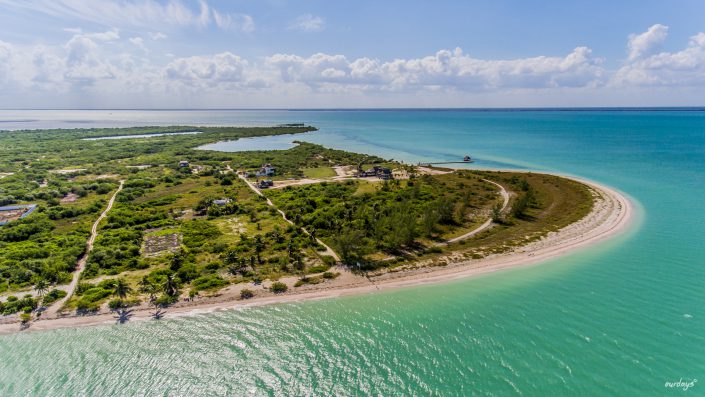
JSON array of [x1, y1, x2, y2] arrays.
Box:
[[0, 174, 634, 335]]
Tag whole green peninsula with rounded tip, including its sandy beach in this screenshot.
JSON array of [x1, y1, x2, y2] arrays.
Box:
[[0, 123, 631, 333]]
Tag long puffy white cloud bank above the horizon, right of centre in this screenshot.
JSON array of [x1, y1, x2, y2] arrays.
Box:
[[266, 47, 604, 90]]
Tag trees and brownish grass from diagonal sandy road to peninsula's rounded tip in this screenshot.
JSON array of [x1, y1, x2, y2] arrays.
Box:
[[267, 171, 593, 270]]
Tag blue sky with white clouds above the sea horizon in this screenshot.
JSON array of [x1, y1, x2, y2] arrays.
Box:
[[0, 0, 705, 109]]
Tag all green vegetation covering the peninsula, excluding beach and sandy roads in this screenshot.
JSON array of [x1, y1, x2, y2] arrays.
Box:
[[0, 126, 592, 314]]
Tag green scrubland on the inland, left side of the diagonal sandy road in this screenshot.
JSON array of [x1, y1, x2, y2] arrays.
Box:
[[0, 126, 382, 311]]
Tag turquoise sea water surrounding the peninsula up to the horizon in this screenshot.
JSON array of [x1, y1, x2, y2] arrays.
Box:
[[0, 110, 705, 396]]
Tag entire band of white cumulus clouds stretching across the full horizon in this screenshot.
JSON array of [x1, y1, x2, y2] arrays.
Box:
[[0, 23, 705, 106]]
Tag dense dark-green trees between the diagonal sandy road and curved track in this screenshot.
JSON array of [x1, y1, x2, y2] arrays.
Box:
[[267, 172, 500, 264]]
